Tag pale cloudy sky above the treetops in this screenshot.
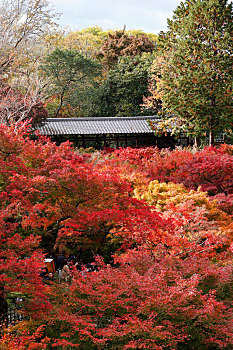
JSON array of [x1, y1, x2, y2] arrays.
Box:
[[50, 0, 180, 34]]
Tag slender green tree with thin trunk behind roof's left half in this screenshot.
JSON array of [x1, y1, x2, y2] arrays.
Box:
[[42, 48, 101, 117]]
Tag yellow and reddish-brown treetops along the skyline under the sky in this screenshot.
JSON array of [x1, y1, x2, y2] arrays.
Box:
[[46, 26, 157, 68]]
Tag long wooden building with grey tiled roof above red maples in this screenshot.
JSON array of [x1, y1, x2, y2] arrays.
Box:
[[36, 116, 188, 149]]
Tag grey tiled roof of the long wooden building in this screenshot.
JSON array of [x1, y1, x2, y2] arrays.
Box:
[[39, 116, 158, 136]]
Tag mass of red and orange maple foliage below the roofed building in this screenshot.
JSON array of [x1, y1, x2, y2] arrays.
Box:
[[0, 123, 233, 350]]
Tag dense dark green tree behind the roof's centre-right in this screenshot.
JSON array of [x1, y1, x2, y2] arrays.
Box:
[[83, 54, 156, 117]]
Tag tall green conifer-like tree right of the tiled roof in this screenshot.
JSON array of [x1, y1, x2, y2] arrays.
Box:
[[147, 0, 233, 145]]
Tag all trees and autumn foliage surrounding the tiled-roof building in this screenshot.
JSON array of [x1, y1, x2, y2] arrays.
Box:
[[0, 0, 233, 350]]
